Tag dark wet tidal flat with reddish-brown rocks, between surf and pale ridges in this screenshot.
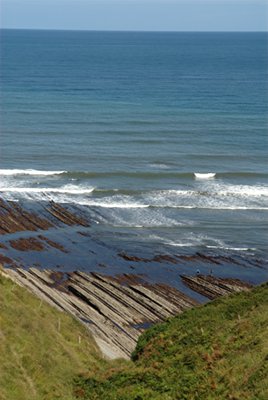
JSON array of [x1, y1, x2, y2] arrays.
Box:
[[0, 198, 267, 288]]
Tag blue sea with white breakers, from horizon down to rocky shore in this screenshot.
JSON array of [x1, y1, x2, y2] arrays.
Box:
[[0, 30, 268, 264]]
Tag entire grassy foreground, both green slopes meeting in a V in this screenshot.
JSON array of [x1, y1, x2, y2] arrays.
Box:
[[0, 270, 268, 400]]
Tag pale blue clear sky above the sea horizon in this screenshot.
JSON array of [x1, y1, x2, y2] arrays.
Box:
[[0, 0, 268, 31]]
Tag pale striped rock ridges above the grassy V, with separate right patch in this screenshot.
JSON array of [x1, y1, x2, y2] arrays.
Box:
[[1, 268, 249, 358]]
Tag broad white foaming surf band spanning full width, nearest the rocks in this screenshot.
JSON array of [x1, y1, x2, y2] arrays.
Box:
[[0, 179, 268, 210]]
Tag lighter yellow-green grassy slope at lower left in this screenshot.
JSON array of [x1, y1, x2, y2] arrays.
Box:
[[0, 275, 115, 400]]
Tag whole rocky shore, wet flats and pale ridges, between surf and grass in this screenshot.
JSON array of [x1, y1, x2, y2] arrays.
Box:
[[0, 200, 266, 359]]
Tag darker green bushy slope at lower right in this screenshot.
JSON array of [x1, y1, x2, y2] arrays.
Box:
[[76, 284, 268, 400]]
